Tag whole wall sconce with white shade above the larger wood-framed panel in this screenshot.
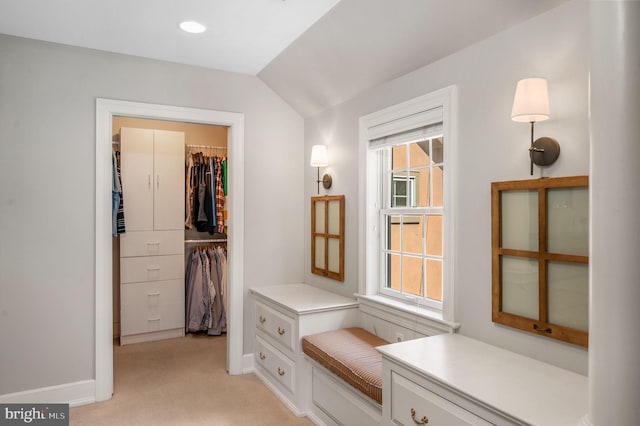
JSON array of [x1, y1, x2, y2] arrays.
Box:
[[511, 78, 560, 175]]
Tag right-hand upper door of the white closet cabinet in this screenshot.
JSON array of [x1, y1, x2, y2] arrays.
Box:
[[153, 130, 185, 230]]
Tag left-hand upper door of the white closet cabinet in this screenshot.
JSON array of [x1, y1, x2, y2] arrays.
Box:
[[120, 128, 152, 232]]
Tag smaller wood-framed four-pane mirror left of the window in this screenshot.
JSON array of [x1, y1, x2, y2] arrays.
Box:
[[311, 195, 344, 281]]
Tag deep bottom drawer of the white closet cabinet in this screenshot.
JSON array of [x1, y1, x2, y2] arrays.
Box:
[[120, 280, 184, 336]]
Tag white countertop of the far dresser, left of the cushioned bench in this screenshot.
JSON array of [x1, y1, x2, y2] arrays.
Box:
[[250, 284, 358, 315]]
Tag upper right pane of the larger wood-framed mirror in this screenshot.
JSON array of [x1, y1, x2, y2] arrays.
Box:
[[547, 187, 589, 256]]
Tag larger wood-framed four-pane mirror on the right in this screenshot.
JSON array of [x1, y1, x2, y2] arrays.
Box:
[[491, 176, 589, 347]]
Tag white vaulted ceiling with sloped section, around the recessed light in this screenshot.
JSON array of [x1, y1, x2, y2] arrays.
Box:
[[0, 0, 567, 116]]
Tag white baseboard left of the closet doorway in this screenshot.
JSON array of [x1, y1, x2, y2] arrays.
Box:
[[0, 380, 96, 407]]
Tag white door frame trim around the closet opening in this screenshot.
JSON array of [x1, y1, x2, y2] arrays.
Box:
[[95, 98, 244, 401]]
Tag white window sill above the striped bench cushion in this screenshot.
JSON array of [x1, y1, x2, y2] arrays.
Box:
[[354, 294, 460, 336]]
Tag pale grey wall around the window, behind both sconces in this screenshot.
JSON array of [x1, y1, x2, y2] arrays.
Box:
[[304, 0, 589, 374]]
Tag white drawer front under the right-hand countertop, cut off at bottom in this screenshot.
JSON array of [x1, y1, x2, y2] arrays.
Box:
[[391, 371, 491, 426]]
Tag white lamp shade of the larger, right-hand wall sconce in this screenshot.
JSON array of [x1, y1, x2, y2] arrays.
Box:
[[511, 78, 549, 123]]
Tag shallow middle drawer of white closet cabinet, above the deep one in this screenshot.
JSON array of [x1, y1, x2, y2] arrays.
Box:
[[120, 254, 184, 283]]
